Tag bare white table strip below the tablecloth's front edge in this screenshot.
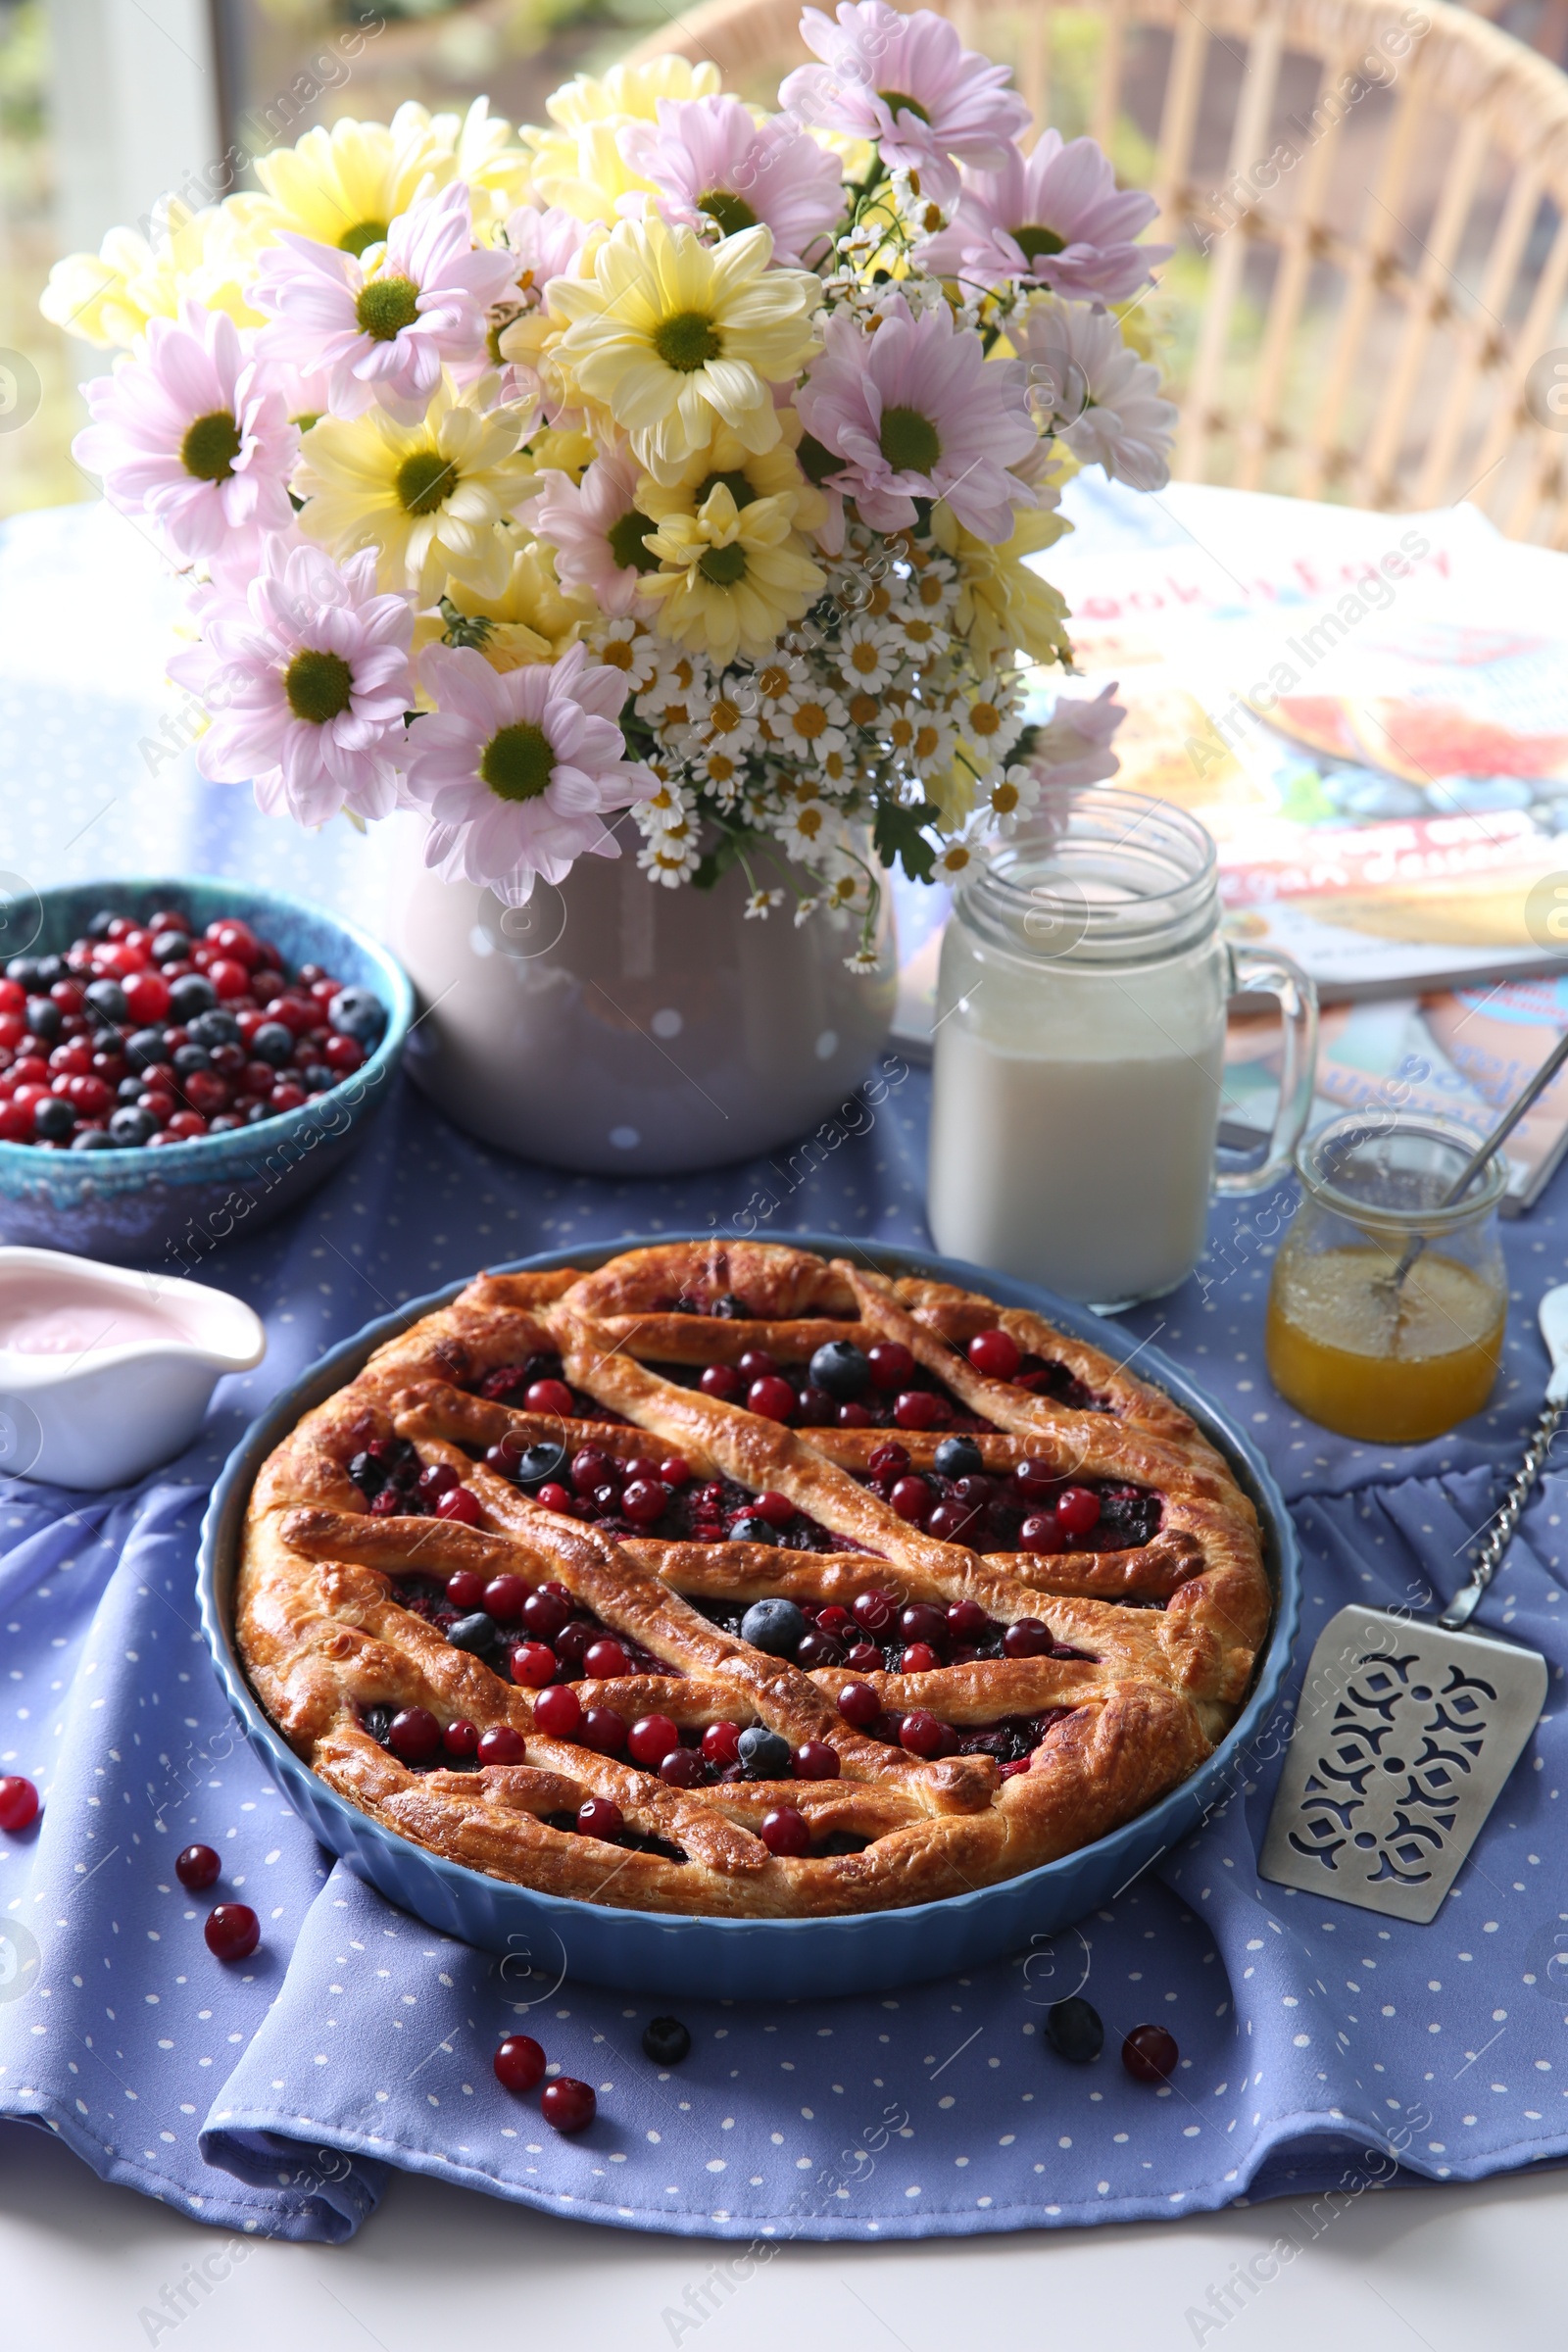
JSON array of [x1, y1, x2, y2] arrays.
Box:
[[0, 2124, 1568, 2352]]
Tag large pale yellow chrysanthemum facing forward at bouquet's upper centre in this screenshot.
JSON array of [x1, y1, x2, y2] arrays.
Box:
[[550, 219, 823, 482]]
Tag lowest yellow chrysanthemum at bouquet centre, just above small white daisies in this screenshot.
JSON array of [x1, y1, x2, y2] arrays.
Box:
[[642, 482, 825, 668]]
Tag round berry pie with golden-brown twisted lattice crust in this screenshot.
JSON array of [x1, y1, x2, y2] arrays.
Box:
[[237, 1242, 1269, 1917]]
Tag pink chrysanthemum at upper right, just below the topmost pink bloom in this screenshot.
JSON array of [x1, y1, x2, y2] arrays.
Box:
[[921, 131, 1175, 301]]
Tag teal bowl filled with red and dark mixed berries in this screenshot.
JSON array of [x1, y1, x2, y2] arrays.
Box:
[[0, 880, 414, 1272]]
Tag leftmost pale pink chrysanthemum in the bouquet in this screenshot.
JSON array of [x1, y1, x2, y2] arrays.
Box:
[[71, 301, 299, 564]]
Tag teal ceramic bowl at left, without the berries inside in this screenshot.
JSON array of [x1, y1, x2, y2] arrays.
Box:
[[0, 875, 414, 1275]]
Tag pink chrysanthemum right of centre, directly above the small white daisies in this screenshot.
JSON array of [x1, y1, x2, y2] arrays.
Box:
[[797, 294, 1037, 543]]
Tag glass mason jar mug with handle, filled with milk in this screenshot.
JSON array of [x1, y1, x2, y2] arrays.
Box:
[[929, 786, 1316, 1307]]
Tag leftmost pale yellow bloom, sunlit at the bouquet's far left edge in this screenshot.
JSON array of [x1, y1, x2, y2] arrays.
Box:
[[37, 200, 264, 351]]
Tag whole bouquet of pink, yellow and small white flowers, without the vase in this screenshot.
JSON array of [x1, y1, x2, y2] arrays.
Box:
[[45, 0, 1175, 969]]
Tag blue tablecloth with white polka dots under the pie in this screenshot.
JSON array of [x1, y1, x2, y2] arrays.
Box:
[[0, 496, 1568, 2241]]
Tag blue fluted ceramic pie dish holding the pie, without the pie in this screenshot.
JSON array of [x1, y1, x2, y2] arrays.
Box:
[[197, 1233, 1300, 2001]]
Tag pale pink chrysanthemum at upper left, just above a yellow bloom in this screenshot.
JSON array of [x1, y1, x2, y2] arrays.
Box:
[[252, 181, 513, 425]]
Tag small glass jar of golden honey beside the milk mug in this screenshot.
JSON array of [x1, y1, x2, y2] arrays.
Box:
[[1265, 1110, 1507, 1445]]
